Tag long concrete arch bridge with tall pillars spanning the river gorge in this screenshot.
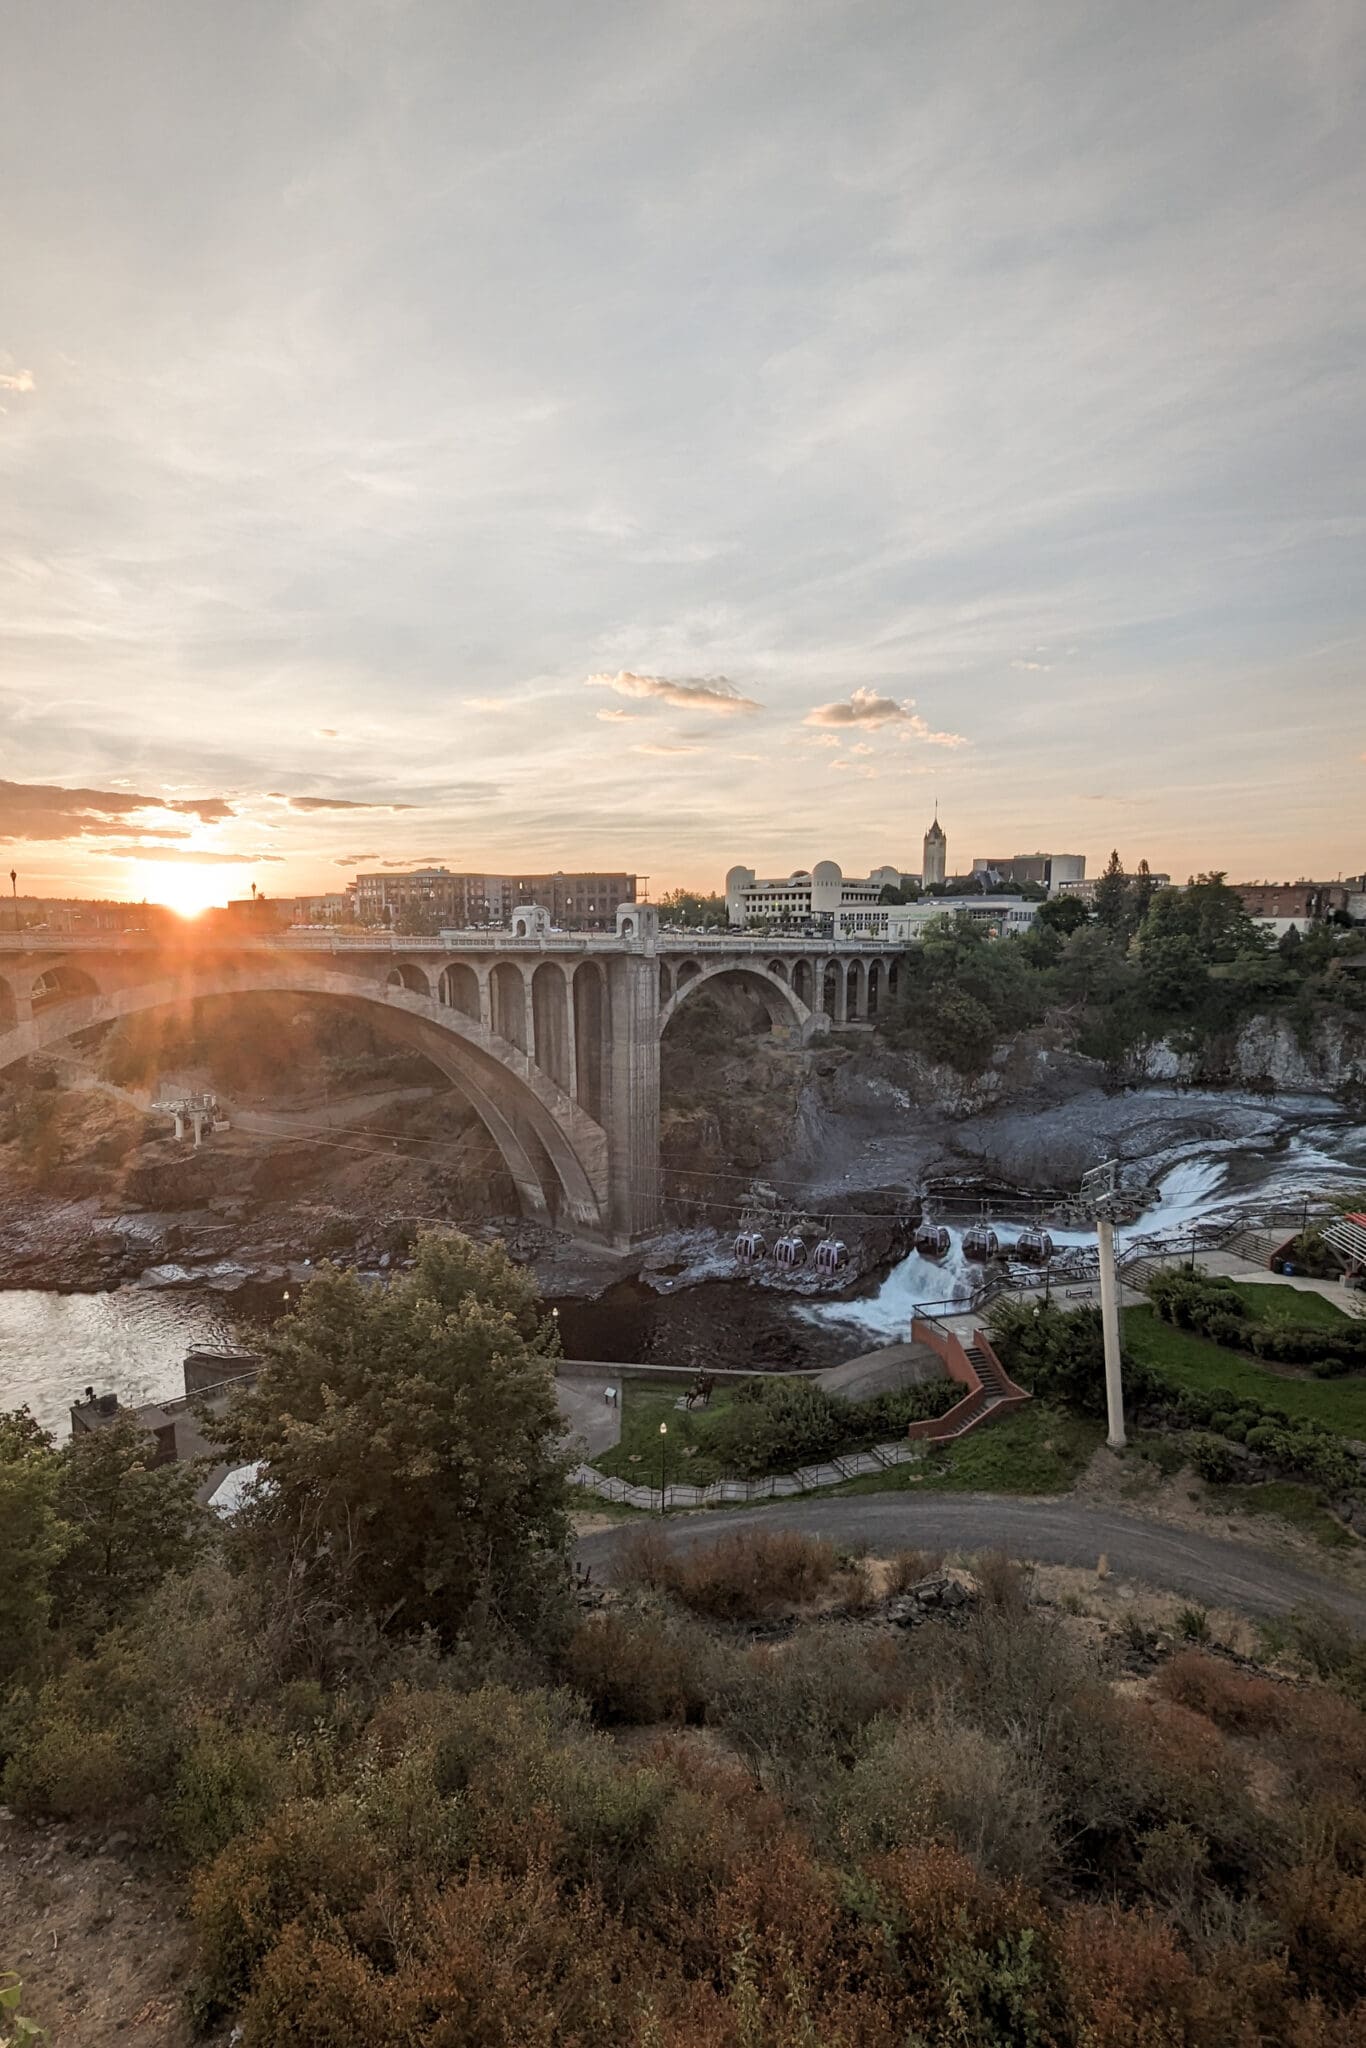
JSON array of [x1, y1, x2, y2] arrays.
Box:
[[0, 903, 903, 1245]]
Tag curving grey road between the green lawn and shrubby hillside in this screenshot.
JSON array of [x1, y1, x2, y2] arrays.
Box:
[[578, 1493, 1366, 1630]]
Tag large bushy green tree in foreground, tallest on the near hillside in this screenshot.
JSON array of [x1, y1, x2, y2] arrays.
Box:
[[223, 1235, 567, 1640]]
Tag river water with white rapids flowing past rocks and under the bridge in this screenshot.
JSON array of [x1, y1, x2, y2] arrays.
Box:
[[0, 1104, 1366, 1436]]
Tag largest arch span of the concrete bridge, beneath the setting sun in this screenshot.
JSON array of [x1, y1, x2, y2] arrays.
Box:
[[0, 970, 610, 1233]]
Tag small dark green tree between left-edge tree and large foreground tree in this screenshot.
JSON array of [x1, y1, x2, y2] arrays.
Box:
[[53, 1413, 213, 1628]]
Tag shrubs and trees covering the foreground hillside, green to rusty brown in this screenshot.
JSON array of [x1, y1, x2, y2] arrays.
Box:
[[0, 1239, 1366, 2048]]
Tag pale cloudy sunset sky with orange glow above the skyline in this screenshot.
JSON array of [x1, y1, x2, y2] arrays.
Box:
[[0, 0, 1366, 903]]
